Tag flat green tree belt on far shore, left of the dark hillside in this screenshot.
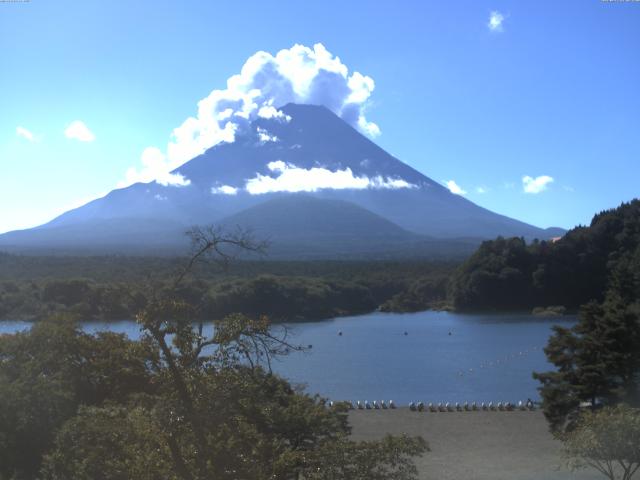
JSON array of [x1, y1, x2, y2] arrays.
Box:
[[0, 255, 454, 321]]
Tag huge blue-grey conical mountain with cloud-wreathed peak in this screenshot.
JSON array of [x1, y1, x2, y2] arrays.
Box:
[[0, 104, 558, 256]]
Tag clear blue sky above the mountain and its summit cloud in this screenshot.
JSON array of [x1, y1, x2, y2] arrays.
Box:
[[0, 0, 640, 232]]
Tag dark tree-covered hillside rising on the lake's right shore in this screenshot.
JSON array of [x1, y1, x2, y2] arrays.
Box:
[[450, 199, 640, 310]]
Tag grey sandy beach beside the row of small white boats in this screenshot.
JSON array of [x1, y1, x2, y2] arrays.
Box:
[[349, 408, 603, 480]]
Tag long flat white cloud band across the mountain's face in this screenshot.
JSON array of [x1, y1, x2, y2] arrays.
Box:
[[245, 160, 417, 195]]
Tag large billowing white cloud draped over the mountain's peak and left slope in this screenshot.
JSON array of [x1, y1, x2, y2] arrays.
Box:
[[122, 43, 380, 188]]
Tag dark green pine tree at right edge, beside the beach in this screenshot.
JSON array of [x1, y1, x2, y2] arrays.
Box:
[[534, 259, 640, 431]]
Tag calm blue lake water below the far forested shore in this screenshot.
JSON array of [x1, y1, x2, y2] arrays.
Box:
[[0, 312, 573, 404]]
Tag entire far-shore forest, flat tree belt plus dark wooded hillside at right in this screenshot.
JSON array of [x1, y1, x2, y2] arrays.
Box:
[[0, 200, 640, 322]]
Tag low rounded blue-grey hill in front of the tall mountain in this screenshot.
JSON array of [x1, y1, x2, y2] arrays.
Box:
[[219, 194, 480, 259]]
